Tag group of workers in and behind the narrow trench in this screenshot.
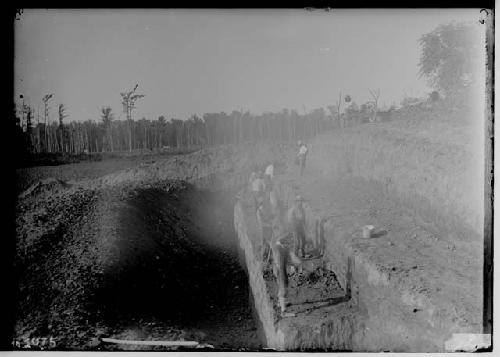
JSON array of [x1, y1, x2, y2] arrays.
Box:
[[250, 142, 309, 314]]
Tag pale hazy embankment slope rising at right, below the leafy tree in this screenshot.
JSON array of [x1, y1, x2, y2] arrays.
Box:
[[308, 98, 484, 233]]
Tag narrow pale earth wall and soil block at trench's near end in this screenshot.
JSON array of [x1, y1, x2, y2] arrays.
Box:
[[234, 197, 359, 351]]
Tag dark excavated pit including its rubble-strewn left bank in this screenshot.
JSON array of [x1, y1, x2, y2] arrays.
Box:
[[14, 181, 262, 350]]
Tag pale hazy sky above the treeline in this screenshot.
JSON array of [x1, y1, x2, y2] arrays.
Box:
[[15, 9, 480, 120]]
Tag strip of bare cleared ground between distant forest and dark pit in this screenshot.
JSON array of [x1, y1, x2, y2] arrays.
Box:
[[16, 143, 293, 194]]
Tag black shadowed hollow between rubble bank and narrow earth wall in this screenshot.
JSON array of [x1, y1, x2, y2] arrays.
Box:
[[96, 182, 262, 350]]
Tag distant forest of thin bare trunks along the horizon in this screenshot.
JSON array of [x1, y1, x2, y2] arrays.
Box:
[[16, 86, 392, 154]]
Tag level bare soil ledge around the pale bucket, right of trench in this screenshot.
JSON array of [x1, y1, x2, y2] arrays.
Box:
[[281, 172, 483, 333]]
